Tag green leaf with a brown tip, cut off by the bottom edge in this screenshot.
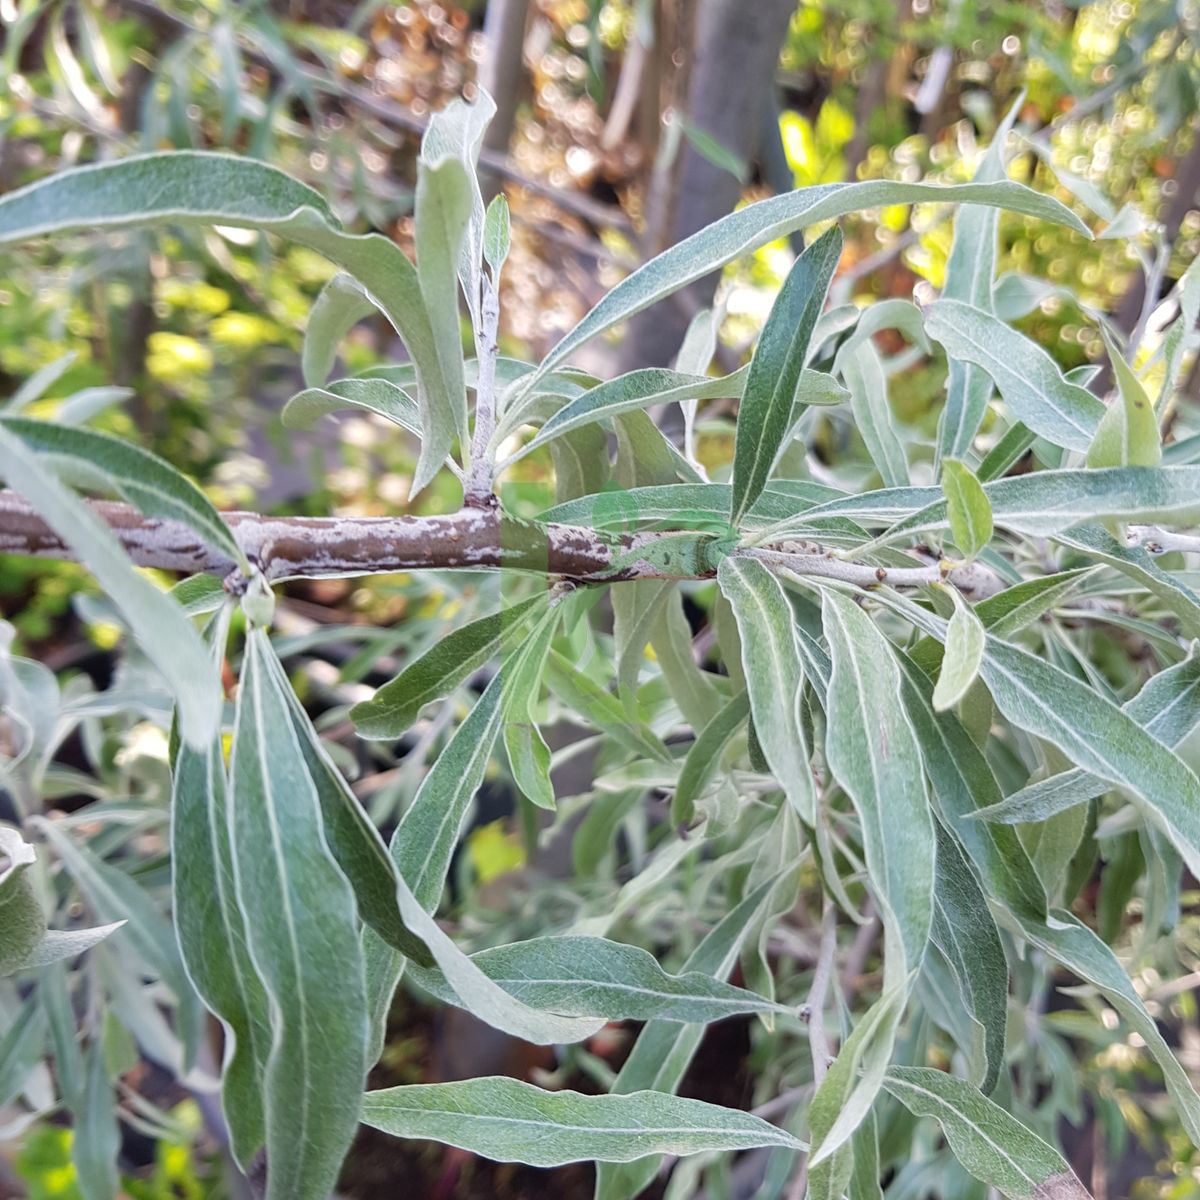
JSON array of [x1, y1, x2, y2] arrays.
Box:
[[883, 1067, 1091, 1200]]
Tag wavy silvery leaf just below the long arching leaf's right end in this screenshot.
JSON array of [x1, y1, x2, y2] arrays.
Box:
[[925, 300, 1104, 450]]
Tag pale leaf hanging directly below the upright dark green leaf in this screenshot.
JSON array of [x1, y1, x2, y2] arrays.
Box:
[[716, 557, 816, 826]]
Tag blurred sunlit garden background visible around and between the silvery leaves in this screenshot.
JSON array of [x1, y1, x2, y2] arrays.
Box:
[[0, 0, 1200, 1200]]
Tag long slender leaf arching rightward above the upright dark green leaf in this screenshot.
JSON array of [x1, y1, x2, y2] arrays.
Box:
[[530, 180, 1087, 382]]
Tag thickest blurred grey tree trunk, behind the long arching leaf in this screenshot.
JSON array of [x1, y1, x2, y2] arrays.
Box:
[[618, 0, 796, 370]]
